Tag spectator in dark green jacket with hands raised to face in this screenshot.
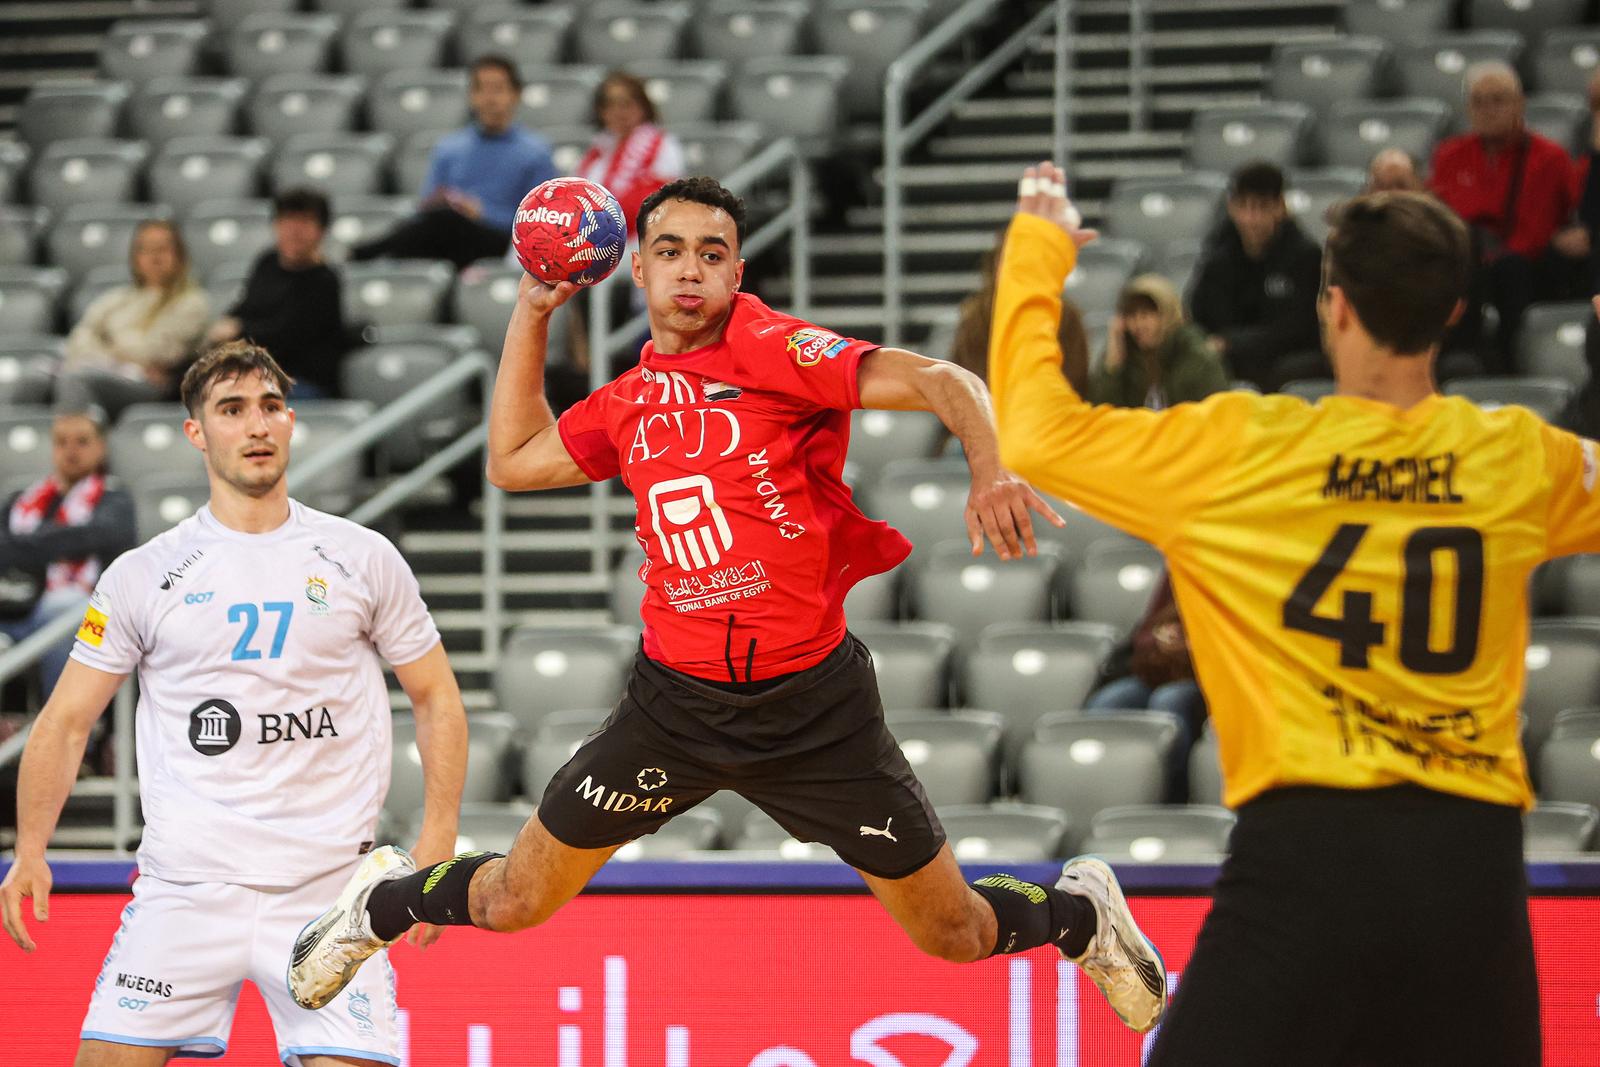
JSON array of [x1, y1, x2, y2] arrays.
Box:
[[1083, 274, 1227, 410]]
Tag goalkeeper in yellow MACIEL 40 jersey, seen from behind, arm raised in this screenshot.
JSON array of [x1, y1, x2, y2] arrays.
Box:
[[989, 163, 1568, 1067]]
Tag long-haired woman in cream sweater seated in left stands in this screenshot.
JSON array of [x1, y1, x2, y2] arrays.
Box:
[[56, 219, 211, 419]]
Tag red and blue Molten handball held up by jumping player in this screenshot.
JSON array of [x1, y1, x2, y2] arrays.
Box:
[[510, 178, 627, 285]]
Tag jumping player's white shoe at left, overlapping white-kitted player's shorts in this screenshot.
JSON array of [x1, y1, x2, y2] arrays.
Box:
[[288, 845, 416, 1009]]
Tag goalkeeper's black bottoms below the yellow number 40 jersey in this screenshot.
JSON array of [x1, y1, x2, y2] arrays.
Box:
[[1149, 785, 1539, 1067]]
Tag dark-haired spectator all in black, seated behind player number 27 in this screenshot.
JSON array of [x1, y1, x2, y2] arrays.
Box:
[[206, 189, 350, 398]]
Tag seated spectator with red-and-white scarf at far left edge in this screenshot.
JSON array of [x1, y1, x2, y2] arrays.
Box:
[[0, 411, 138, 694]]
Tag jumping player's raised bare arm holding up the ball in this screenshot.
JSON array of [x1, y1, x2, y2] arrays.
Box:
[[488, 275, 589, 490]]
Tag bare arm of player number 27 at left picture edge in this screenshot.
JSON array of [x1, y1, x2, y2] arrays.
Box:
[[0, 659, 126, 952]]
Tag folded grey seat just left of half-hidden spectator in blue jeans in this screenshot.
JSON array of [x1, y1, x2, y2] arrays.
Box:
[[957, 622, 1115, 761]]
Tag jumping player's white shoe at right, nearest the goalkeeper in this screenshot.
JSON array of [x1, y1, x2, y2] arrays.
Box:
[[1056, 856, 1166, 1033]]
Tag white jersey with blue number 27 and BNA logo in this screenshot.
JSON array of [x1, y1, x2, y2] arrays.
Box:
[[72, 501, 438, 886]]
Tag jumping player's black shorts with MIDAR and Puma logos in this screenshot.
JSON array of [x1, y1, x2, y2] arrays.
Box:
[[539, 633, 944, 878]]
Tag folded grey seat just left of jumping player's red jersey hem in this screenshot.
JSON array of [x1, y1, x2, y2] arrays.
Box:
[[494, 627, 634, 735]]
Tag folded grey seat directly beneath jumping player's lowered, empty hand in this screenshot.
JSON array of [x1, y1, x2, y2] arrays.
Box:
[[906, 539, 1062, 645]]
